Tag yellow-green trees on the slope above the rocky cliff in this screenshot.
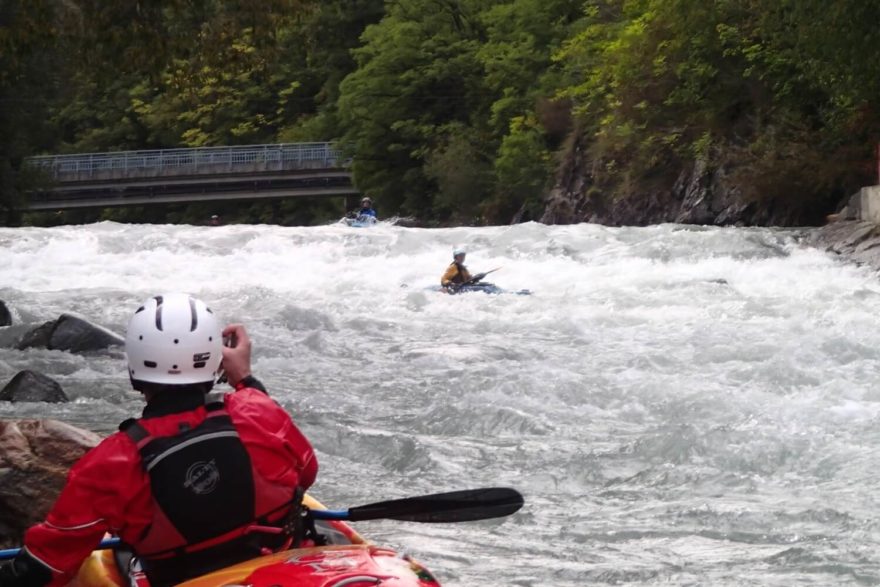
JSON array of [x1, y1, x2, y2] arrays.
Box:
[[557, 0, 877, 221]]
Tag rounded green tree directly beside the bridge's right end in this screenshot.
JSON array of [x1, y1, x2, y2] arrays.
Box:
[[339, 0, 482, 220]]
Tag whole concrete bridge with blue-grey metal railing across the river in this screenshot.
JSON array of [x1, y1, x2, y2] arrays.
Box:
[[27, 143, 358, 210]]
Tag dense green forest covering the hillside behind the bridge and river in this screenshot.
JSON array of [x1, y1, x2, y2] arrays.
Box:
[[0, 0, 880, 224]]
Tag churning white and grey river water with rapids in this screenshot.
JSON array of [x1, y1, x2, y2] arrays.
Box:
[[0, 223, 880, 587]]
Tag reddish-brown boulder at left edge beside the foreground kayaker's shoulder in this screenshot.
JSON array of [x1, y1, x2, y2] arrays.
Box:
[[0, 420, 101, 548]]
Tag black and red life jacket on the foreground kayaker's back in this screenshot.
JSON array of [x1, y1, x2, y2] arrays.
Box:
[[119, 403, 265, 587]]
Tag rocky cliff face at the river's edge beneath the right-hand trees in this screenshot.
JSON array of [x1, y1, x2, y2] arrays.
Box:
[[541, 149, 824, 226]]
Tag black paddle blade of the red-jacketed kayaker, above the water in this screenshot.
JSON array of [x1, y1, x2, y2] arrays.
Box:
[[348, 487, 524, 523]]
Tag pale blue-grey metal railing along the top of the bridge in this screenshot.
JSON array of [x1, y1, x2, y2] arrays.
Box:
[[27, 143, 347, 181]]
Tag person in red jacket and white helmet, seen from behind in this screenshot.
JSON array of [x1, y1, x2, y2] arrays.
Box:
[[0, 294, 318, 587]]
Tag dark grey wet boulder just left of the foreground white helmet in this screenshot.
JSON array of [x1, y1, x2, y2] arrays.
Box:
[[16, 313, 125, 353]]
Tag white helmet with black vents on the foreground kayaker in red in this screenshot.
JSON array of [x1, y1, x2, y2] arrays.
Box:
[[125, 293, 223, 385]]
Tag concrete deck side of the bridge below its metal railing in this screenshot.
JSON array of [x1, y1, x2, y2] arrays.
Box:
[[27, 170, 358, 210]]
